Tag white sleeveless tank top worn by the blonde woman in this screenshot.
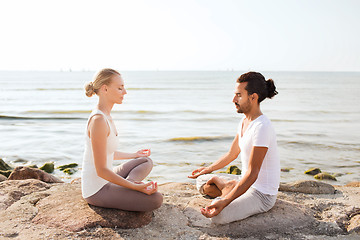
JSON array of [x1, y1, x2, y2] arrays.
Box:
[[81, 109, 119, 198]]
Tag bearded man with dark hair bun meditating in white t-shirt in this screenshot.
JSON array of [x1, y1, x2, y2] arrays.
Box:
[[189, 72, 280, 224]]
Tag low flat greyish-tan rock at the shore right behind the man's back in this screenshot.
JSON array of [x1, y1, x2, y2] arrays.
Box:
[[279, 180, 335, 194]]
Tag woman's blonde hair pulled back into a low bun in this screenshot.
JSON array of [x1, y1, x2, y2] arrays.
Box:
[[85, 68, 121, 97]]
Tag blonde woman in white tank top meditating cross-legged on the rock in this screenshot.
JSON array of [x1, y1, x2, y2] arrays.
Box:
[[81, 69, 163, 211]]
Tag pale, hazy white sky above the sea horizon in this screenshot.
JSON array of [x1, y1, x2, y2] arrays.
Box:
[[0, 0, 360, 71]]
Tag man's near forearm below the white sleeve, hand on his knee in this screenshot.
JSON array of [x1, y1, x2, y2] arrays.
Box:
[[201, 147, 268, 218]]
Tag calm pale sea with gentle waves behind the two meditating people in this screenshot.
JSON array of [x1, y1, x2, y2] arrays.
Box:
[[0, 71, 360, 185]]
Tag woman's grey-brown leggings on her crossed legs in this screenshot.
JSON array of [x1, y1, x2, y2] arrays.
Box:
[[85, 157, 163, 212]]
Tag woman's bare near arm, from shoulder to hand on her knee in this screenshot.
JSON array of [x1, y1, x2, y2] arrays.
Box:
[[89, 115, 157, 195]]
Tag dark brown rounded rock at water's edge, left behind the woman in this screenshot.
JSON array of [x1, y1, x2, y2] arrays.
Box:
[[8, 166, 63, 183]]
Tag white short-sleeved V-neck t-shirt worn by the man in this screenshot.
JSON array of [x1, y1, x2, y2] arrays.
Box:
[[238, 115, 280, 195]]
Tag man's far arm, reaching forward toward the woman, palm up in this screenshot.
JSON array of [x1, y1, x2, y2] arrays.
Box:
[[188, 134, 240, 178]]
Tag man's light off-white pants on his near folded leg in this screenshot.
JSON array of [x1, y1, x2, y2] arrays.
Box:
[[211, 187, 276, 224]]
